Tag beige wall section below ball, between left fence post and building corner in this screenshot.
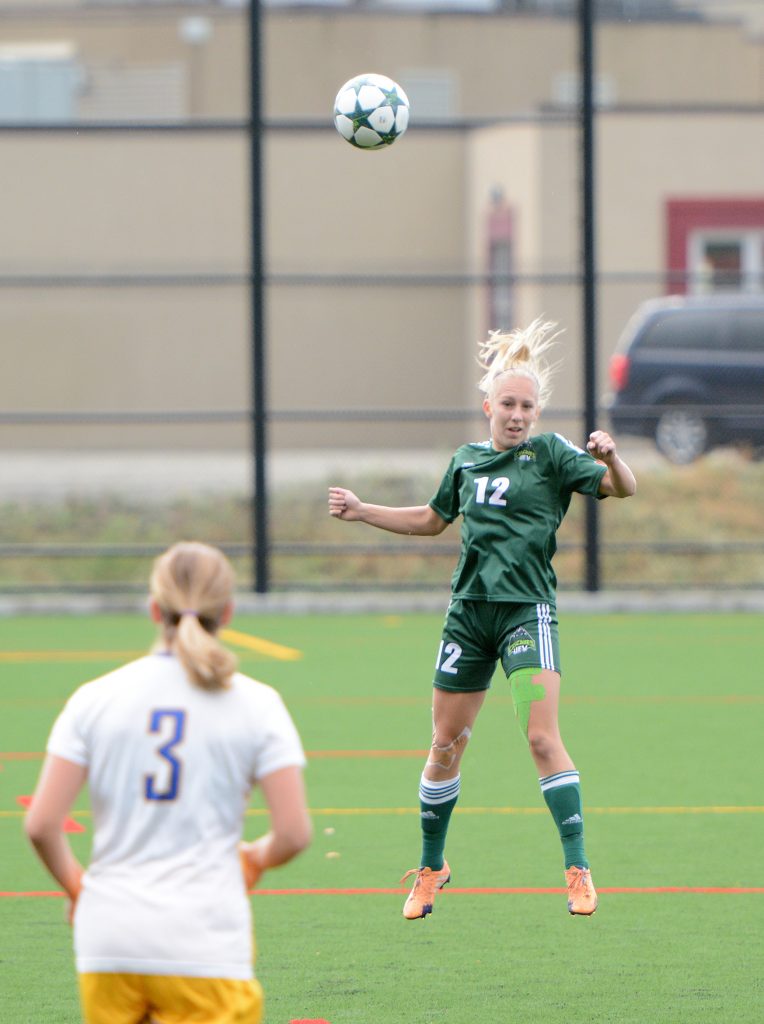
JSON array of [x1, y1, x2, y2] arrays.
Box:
[[266, 126, 468, 447]]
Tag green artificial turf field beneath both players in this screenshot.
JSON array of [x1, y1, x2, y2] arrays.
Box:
[[0, 614, 764, 1024]]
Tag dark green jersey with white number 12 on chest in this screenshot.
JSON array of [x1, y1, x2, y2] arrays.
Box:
[[429, 434, 606, 604]]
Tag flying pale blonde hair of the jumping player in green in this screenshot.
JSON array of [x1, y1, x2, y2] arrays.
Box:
[[477, 316, 562, 408]]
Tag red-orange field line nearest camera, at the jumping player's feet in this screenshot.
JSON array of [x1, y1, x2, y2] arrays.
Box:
[[0, 886, 764, 899]]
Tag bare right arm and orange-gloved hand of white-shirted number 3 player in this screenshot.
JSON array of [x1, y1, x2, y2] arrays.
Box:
[[239, 767, 313, 889]]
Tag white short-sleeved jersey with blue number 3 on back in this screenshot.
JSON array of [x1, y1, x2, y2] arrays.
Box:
[[47, 653, 305, 979]]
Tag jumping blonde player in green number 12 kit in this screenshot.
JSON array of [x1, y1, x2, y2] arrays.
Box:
[[329, 319, 636, 920]]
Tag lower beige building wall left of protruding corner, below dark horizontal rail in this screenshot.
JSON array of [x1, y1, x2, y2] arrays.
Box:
[[0, 125, 467, 447]]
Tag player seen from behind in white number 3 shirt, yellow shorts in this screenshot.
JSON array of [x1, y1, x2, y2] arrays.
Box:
[[26, 543, 311, 1024]]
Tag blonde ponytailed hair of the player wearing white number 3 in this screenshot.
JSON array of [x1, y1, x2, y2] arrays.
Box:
[[151, 542, 237, 690]]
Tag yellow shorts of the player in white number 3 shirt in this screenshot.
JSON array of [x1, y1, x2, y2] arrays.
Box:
[[79, 974, 262, 1024]]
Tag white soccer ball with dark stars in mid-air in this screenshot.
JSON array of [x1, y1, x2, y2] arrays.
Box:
[[334, 75, 409, 150]]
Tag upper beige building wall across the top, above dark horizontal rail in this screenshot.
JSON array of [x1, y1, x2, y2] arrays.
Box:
[[0, 7, 764, 120]]
